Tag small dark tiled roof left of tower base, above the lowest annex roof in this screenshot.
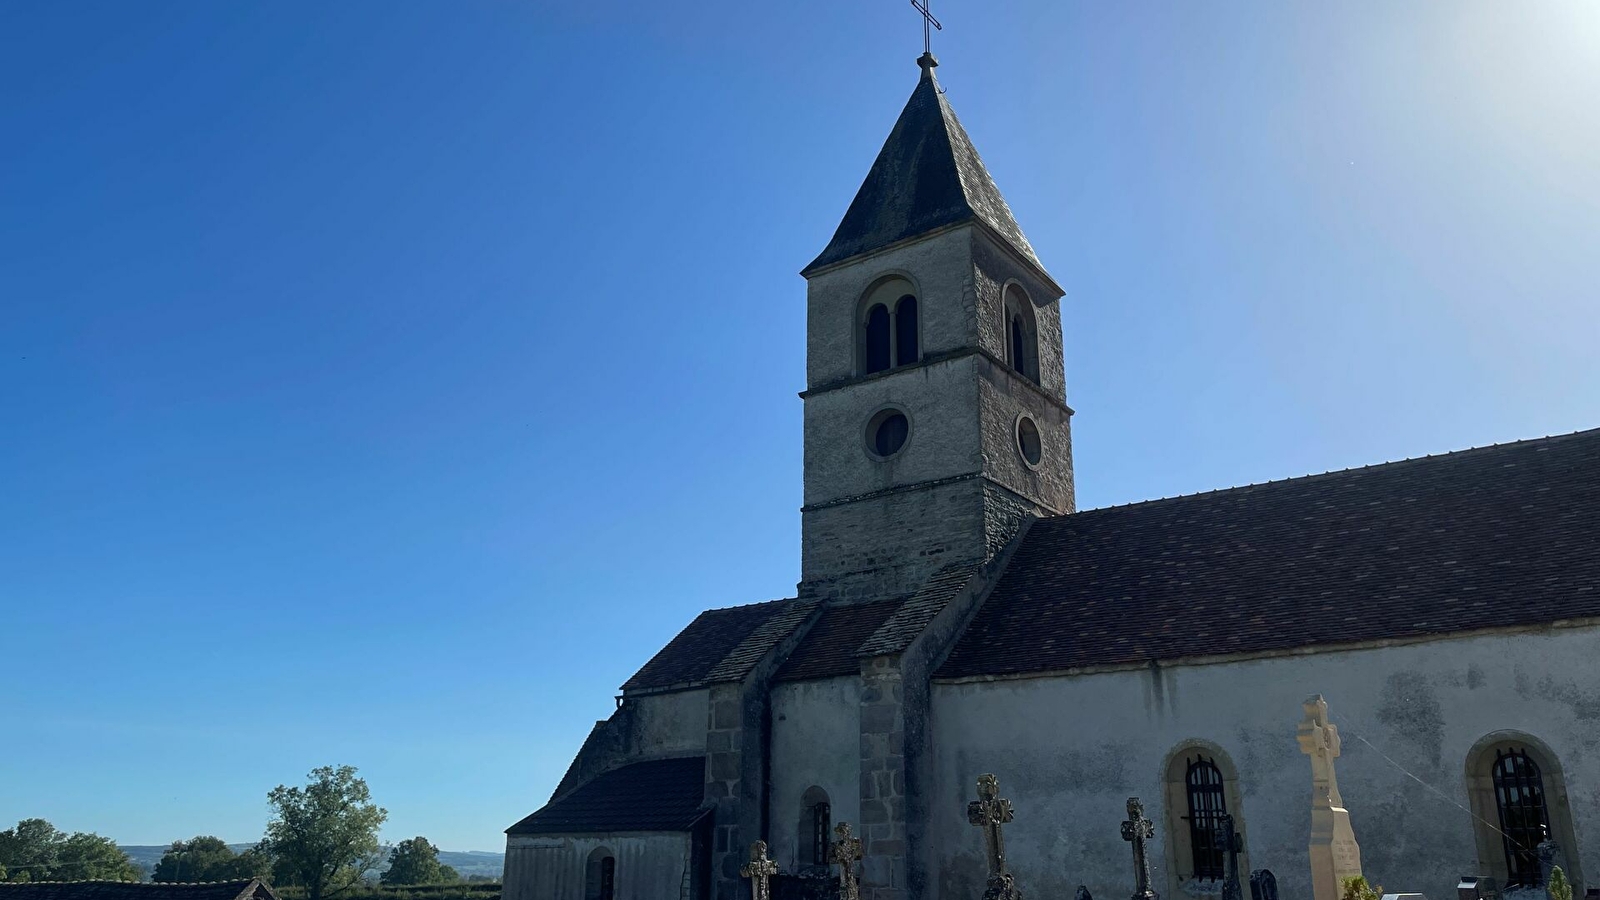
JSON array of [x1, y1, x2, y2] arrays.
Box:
[[622, 601, 813, 690]]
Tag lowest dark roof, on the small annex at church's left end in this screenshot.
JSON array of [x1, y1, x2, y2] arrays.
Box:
[[506, 756, 706, 834]]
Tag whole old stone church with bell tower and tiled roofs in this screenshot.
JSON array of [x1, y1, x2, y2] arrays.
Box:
[[504, 53, 1600, 900]]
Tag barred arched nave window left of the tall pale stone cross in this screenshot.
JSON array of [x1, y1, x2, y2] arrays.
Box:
[[1165, 741, 1250, 897]]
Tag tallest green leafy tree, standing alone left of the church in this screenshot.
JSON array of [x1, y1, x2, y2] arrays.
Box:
[[261, 765, 389, 900]]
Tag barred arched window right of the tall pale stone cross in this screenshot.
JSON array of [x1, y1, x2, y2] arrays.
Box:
[[1467, 732, 1582, 887]]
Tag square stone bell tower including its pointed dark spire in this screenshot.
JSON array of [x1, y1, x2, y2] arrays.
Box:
[[800, 53, 1074, 601]]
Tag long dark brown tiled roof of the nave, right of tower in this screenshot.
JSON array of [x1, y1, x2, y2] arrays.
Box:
[[936, 429, 1600, 677]]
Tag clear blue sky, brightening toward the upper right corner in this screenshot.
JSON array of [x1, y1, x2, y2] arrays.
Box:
[[0, 0, 1600, 850]]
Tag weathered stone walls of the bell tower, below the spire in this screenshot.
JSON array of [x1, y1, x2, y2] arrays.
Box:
[[800, 224, 1074, 601]]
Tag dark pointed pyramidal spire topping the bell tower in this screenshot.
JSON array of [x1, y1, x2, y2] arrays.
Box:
[[800, 53, 1048, 277]]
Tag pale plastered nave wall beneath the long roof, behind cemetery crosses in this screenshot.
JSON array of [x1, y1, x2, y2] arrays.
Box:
[[930, 628, 1600, 900]]
